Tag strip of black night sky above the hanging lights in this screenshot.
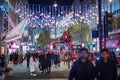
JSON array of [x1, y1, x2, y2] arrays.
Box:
[[28, 0, 74, 5]]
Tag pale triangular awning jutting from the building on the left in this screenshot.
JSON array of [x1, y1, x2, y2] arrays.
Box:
[[4, 18, 28, 42]]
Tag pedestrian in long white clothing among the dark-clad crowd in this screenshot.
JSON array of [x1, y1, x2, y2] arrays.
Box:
[[29, 53, 36, 76]]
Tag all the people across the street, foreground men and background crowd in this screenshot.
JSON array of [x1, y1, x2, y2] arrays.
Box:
[[0, 48, 120, 80]]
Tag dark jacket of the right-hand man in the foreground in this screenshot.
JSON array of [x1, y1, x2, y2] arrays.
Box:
[[96, 58, 117, 80]]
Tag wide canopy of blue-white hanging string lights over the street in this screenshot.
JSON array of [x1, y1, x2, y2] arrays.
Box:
[[10, 2, 97, 38]]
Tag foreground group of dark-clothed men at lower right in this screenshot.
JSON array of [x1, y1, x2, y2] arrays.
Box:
[[69, 48, 120, 80]]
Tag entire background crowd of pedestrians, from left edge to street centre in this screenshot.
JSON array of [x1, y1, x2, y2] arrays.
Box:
[[0, 51, 60, 80]]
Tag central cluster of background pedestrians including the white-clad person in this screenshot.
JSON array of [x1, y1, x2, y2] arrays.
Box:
[[23, 51, 60, 76]]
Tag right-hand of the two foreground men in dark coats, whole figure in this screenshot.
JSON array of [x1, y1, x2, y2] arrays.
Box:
[[96, 49, 117, 80]]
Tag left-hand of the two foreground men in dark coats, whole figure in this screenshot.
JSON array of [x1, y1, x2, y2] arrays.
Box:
[[69, 48, 94, 80]]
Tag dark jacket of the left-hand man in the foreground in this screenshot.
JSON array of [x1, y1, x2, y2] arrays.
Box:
[[69, 59, 94, 80]]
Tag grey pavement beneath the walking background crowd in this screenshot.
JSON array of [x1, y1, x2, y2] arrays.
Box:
[[7, 61, 72, 80]]
